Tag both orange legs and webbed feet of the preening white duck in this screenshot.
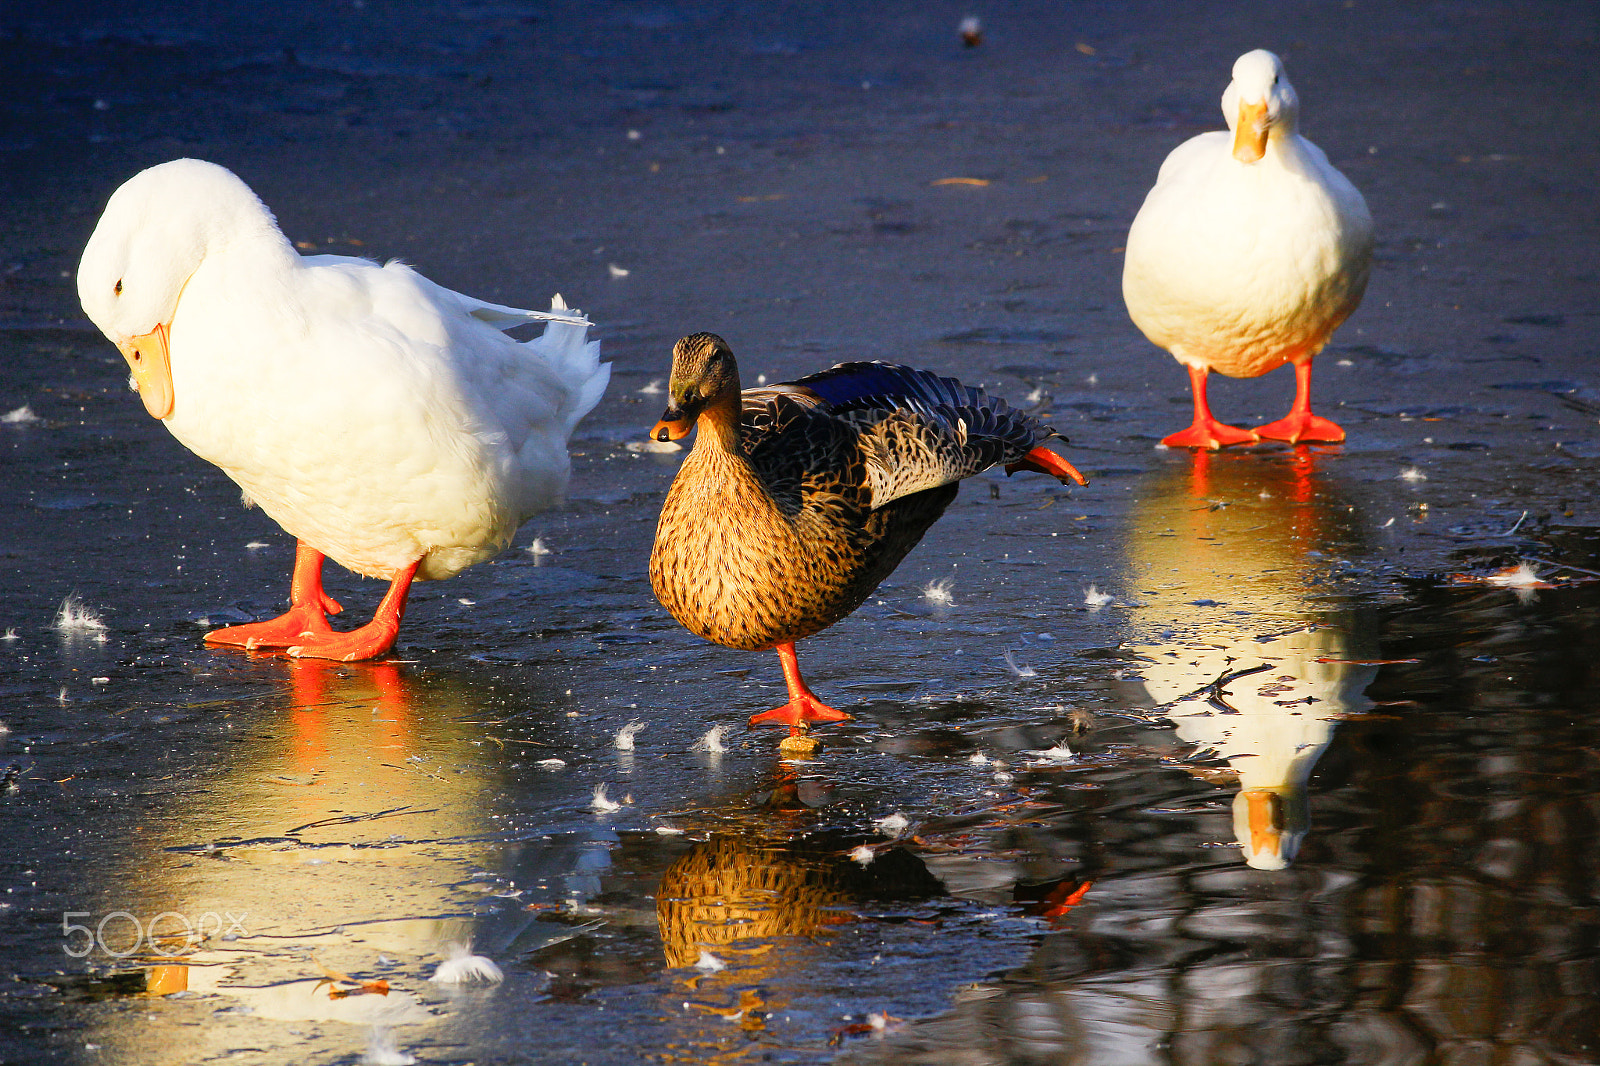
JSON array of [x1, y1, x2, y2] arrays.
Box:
[[205, 544, 421, 663]]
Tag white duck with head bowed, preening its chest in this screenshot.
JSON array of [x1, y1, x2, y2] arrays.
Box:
[[78, 158, 611, 659]]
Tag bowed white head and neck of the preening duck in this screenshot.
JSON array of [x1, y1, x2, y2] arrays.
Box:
[[78, 158, 283, 418]]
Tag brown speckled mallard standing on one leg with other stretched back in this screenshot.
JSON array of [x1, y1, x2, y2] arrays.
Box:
[[650, 333, 1088, 736]]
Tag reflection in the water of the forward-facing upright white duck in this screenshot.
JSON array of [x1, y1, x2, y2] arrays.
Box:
[[1128, 448, 1376, 869]]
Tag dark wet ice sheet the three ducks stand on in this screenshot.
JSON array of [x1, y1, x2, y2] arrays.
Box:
[[0, 3, 1600, 1064]]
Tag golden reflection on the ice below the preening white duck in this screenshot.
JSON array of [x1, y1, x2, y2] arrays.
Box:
[[75, 659, 520, 1061]]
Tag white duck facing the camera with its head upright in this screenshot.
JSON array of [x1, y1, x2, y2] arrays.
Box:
[[1122, 50, 1373, 448]]
